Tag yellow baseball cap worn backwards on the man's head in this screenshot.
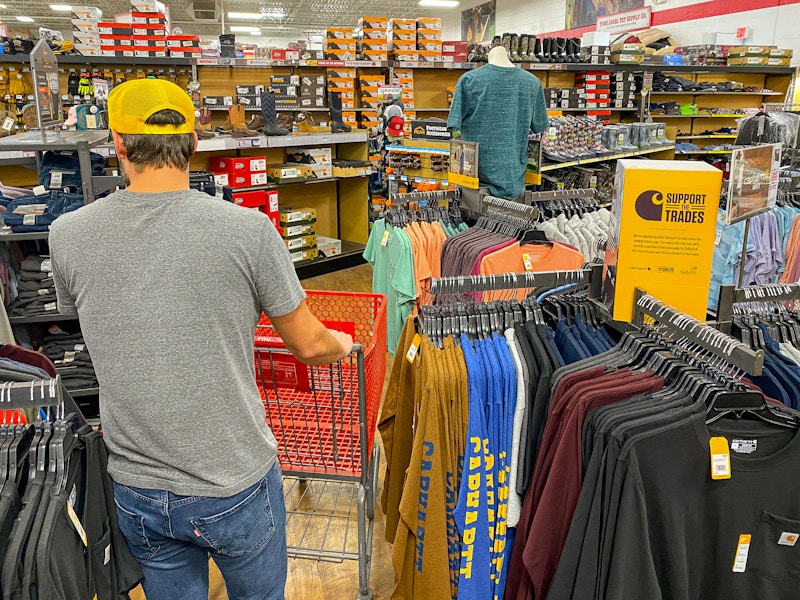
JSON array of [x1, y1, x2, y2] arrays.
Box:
[[108, 79, 195, 135]]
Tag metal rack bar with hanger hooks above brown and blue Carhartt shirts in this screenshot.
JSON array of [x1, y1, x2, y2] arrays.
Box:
[[430, 264, 603, 298]]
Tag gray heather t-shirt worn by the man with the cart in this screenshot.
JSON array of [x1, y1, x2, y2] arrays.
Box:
[[50, 190, 305, 497]]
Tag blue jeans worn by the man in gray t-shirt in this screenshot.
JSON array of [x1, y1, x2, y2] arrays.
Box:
[[114, 463, 287, 600]]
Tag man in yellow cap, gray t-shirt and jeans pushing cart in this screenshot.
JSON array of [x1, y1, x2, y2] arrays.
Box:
[[50, 79, 352, 600]]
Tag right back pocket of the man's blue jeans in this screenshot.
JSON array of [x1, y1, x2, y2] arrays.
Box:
[[191, 481, 275, 557]]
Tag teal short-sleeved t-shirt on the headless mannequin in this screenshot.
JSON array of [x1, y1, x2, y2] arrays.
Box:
[[447, 64, 549, 199]]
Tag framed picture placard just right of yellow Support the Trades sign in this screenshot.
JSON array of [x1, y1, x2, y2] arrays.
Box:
[[725, 144, 783, 225]]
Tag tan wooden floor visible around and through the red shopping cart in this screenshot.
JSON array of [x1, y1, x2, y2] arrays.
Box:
[[131, 265, 394, 600]]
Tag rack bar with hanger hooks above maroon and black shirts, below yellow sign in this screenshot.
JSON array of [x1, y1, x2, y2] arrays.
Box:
[[632, 288, 764, 376]]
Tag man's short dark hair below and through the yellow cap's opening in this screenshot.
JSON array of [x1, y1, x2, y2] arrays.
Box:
[[122, 108, 194, 173]]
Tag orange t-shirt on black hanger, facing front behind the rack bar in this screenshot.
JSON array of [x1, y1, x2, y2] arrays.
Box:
[[481, 242, 586, 302]]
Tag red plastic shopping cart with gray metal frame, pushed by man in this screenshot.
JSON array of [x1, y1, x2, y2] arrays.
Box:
[[255, 291, 386, 600]]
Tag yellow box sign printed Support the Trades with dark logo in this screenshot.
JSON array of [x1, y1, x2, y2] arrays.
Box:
[[603, 160, 722, 322]]
